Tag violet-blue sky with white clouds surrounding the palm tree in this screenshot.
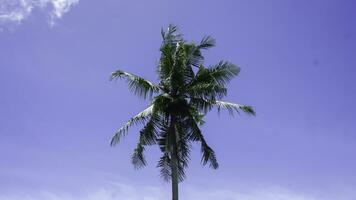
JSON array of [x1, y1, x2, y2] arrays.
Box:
[[0, 0, 356, 200]]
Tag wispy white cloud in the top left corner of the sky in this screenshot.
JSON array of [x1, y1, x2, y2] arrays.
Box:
[[0, 0, 79, 25]]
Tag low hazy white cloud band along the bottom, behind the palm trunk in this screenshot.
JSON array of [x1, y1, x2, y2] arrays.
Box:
[[0, 183, 321, 200]]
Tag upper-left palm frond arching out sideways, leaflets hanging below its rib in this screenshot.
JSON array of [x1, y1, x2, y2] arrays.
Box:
[[110, 70, 159, 99]]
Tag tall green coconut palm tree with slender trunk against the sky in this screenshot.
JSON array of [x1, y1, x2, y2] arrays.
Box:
[[111, 25, 255, 200]]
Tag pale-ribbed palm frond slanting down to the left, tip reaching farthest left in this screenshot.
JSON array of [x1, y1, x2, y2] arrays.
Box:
[[110, 104, 154, 146]]
